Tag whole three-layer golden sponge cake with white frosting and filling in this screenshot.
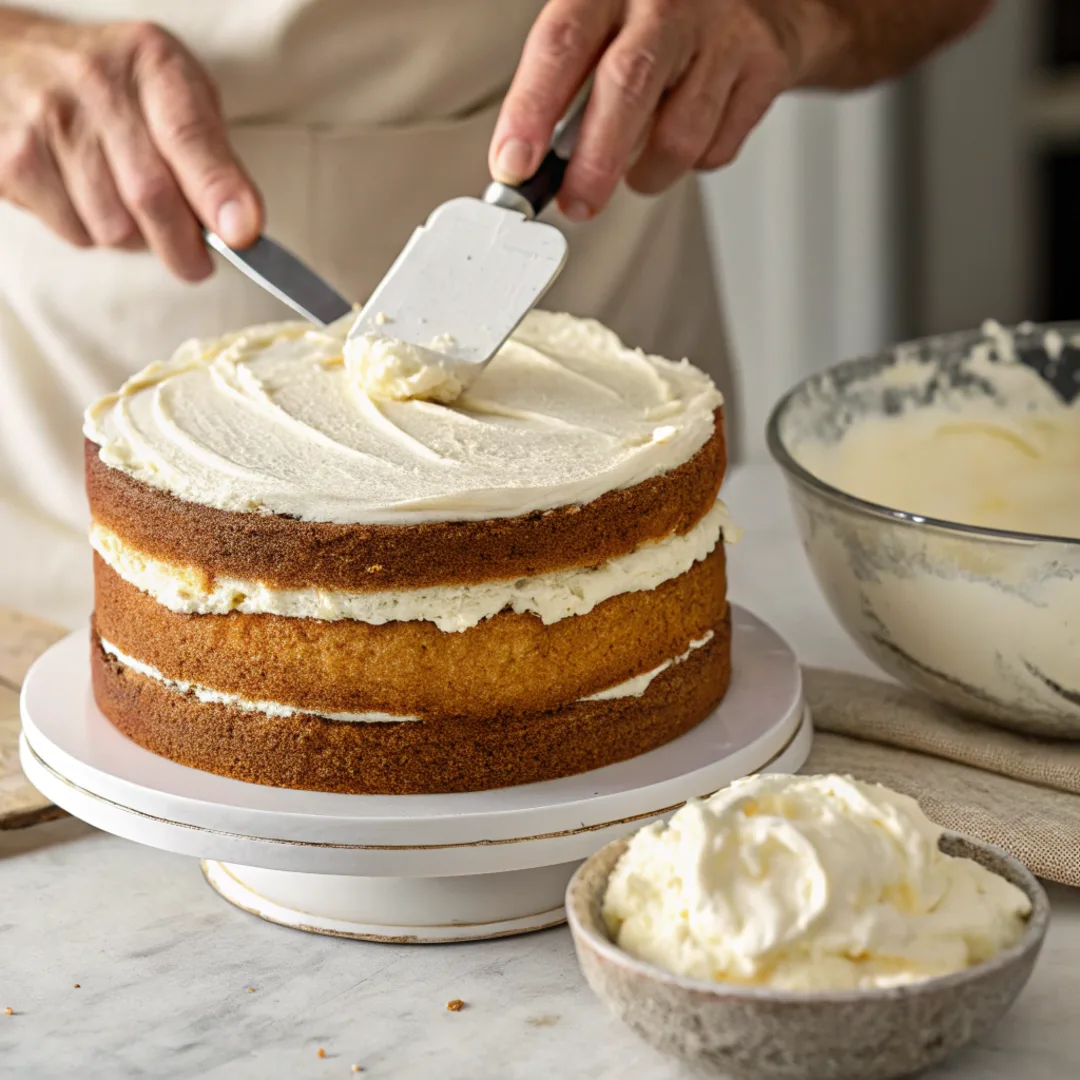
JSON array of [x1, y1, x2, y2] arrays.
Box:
[[85, 311, 730, 794]]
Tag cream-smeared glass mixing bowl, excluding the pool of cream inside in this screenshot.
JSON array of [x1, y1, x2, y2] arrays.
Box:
[[768, 324, 1080, 738]]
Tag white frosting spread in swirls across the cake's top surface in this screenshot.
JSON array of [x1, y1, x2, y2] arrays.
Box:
[[83, 311, 721, 524]]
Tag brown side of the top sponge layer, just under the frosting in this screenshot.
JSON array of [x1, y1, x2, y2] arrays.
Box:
[[85, 409, 727, 592]]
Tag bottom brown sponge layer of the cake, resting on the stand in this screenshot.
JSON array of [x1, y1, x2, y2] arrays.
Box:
[[91, 617, 731, 795]]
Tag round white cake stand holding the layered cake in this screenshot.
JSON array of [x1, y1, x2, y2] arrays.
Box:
[[19, 608, 811, 942]]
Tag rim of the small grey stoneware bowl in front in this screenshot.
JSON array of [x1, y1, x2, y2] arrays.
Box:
[[566, 829, 1050, 1005]]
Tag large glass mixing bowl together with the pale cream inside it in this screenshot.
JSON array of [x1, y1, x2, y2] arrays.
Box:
[[769, 323, 1080, 738]]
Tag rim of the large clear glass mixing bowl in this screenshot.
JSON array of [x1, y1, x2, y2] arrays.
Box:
[[765, 322, 1080, 548]]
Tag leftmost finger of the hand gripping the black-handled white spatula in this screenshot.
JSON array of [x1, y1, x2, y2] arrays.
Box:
[[488, 0, 622, 184]]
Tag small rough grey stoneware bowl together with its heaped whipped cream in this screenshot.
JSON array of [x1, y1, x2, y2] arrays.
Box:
[[566, 774, 1050, 1080]]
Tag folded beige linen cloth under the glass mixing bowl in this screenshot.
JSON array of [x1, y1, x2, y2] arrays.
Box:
[[802, 669, 1080, 886]]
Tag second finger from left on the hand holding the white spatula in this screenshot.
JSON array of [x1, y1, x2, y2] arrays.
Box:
[[558, 12, 690, 221]]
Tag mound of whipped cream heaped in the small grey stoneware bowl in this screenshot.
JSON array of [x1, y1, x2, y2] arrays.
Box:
[[604, 775, 1031, 990]]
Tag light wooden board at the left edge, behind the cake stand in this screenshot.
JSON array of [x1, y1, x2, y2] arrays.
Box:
[[0, 608, 67, 828]]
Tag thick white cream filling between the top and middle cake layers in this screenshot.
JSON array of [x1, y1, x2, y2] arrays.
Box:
[[90, 499, 738, 633]]
